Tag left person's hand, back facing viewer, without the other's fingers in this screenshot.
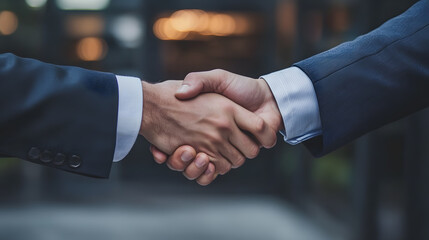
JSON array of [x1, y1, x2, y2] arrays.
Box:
[[140, 81, 276, 174]]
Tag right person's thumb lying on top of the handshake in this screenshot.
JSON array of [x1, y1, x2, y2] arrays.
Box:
[[175, 69, 231, 100]]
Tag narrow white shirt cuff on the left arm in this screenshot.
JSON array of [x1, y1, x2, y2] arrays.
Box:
[[113, 76, 143, 162]]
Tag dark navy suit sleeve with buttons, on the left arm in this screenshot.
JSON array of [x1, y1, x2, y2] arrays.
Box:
[[0, 54, 118, 178]]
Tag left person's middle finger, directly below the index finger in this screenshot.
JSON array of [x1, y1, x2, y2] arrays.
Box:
[[229, 127, 260, 159]]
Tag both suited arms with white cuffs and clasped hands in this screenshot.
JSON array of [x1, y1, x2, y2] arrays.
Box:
[[0, 1, 420, 182]]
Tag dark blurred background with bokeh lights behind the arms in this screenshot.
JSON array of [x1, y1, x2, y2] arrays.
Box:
[[0, 0, 429, 240]]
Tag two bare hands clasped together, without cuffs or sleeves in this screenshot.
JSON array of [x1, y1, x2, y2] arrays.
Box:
[[139, 70, 283, 185]]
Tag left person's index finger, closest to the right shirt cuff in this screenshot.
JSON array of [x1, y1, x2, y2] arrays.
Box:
[[234, 107, 277, 148]]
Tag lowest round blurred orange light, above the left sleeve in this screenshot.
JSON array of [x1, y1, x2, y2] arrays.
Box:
[[76, 37, 107, 61]]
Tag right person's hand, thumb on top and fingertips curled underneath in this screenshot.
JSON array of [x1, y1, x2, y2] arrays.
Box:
[[152, 70, 283, 185]]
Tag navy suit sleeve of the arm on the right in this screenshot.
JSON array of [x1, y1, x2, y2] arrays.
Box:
[[295, 0, 429, 156]]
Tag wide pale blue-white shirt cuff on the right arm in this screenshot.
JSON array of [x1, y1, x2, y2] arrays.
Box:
[[262, 67, 322, 145]]
